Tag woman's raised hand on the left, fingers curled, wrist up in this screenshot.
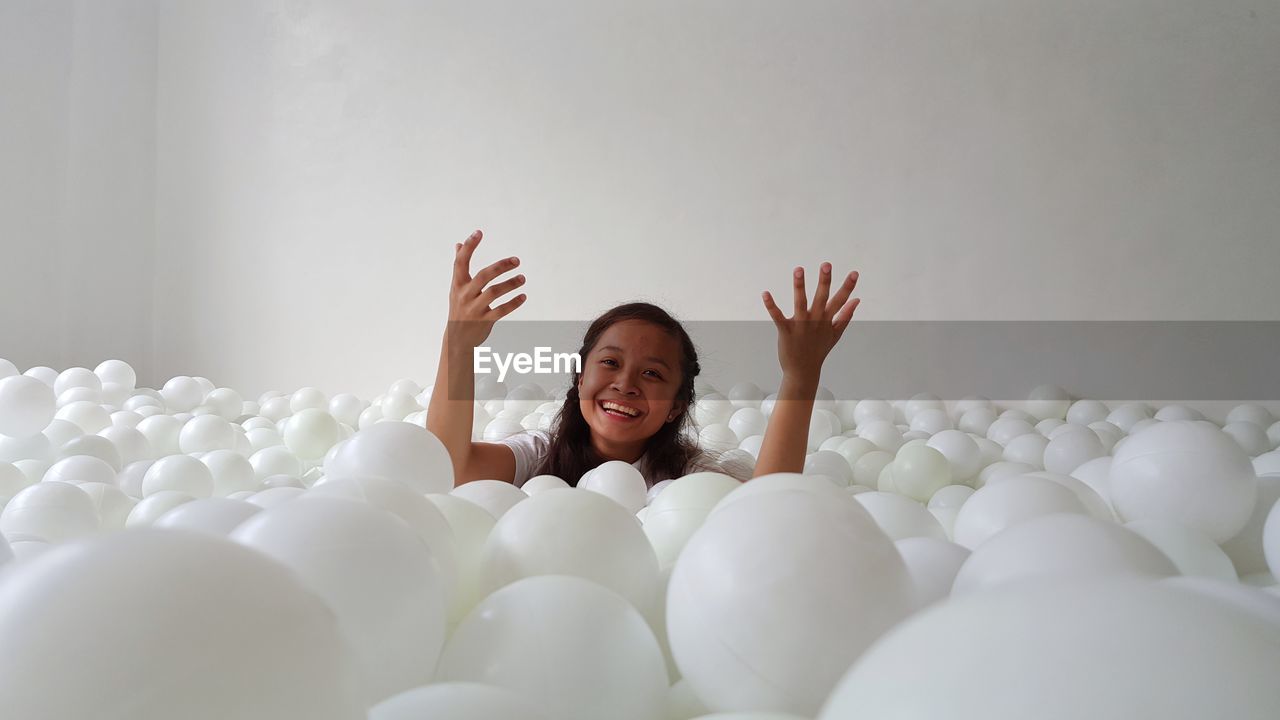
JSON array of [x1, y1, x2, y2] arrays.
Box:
[[445, 225, 526, 350]]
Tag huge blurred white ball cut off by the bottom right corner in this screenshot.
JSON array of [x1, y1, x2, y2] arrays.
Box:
[[817, 580, 1280, 720]]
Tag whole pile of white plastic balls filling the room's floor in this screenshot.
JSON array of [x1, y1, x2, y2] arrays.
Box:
[[0, 360, 1280, 720]]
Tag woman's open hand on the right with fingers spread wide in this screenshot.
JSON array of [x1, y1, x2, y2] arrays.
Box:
[[763, 257, 861, 383]]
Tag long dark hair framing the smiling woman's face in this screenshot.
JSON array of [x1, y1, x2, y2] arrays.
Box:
[[530, 302, 701, 487]]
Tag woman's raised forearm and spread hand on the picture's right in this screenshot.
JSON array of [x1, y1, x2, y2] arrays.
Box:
[[751, 263, 860, 478]]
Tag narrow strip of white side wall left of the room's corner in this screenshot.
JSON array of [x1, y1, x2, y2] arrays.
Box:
[[0, 0, 156, 378]]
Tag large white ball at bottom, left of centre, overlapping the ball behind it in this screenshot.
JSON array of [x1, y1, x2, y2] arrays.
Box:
[[435, 573, 667, 720]]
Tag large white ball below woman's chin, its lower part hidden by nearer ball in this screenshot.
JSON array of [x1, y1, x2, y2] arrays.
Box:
[[478, 486, 658, 616]]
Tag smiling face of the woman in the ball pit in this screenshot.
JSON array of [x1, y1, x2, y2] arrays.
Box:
[[577, 320, 684, 462]]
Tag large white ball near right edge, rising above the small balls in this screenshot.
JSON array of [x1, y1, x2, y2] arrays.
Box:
[[1108, 421, 1258, 543]]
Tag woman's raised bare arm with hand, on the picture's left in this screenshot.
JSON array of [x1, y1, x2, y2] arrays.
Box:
[[426, 231, 525, 486]]
